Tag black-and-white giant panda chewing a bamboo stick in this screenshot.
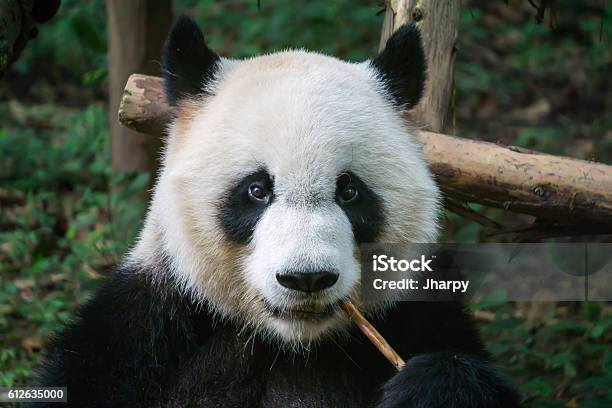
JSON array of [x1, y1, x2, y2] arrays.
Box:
[[33, 17, 520, 408]]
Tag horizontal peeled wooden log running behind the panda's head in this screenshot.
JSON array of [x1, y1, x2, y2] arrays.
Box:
[[119, 74, 612, 226]]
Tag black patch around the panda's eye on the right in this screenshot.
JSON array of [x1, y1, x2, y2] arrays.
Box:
[[336, 172, 384, 244]]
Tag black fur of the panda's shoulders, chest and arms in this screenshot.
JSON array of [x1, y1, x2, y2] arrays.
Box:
[[37, 262, 518, 408]]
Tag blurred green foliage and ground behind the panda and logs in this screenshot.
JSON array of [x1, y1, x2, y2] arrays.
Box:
[[0, 0, 612, 407]]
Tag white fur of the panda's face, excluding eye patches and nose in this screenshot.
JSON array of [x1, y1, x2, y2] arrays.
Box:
[[129, 51, 439, 342]]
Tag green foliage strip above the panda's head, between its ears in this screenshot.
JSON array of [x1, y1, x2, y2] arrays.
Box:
[[176, 0, 382, 61]]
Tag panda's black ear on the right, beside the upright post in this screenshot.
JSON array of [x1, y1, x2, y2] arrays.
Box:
[[371, 24, 427, 109]]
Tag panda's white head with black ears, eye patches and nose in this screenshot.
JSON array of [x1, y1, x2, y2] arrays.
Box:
[[132, 18, 439, 345]]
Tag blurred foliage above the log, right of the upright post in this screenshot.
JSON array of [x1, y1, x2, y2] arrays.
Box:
[[455, 0, 612, 162]]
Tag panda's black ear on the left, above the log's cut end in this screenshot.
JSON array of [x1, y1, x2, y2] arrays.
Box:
[[162, 16, 220, 106]]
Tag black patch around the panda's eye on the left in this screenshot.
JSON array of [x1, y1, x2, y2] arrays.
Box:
[[218, 169, 274, 244]]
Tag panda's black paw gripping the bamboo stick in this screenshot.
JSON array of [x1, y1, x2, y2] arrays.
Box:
[[378, 353, 520, 408]]
